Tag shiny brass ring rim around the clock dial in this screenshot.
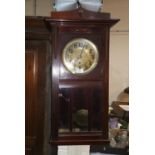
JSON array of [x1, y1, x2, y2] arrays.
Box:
[[62, 38, 99, 75]]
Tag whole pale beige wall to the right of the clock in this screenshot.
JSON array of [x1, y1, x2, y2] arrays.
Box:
[[102, 0, 129, 104]]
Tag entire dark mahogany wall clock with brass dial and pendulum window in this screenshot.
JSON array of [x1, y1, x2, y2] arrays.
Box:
[[45, 8, 119, 145]]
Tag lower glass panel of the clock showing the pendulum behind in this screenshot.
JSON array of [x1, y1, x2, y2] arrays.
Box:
[[59, 82, 103, 133]]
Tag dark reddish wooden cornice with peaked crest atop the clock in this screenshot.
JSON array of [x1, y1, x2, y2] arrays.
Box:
[[45, 8, 119, 26]]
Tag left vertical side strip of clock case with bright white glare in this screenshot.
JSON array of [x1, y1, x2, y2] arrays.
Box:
[[51, 25, 59, 140]]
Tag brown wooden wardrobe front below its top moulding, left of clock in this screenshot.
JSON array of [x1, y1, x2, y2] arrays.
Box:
[[25, 40, 49, 155]]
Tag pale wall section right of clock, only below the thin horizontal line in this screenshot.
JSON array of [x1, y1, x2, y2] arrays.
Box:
[[109, 32, 129, 104]]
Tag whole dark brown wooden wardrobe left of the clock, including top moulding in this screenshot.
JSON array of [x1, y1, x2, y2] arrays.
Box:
[[25, 17, 51, 155]]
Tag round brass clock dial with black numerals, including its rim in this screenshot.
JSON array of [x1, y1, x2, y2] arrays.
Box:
[[62, 38, 99, 75]]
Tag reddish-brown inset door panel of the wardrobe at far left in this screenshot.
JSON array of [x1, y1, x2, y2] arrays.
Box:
[[25, 49, 38, 154]]
